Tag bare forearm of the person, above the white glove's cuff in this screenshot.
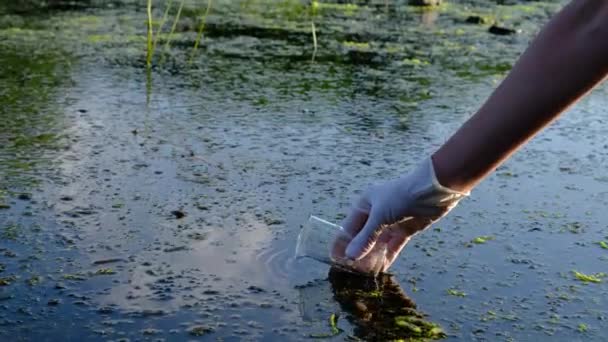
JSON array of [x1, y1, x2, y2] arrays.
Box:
[[433, 0, 608, 191]]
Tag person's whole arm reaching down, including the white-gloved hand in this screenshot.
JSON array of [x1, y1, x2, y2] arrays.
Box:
[[343, 0, 608, 267]]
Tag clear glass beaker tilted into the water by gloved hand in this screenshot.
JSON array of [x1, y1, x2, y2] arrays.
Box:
[[296, 216, 387, 276]]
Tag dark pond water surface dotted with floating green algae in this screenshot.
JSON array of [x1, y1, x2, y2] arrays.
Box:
[[0, 0, 608, 341]]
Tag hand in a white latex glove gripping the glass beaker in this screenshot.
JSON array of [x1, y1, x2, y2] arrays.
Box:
[[342, 158, 468, 270]]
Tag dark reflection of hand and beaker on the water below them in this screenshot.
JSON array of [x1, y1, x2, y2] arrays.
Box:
[[298, 268, 445, 341]]
